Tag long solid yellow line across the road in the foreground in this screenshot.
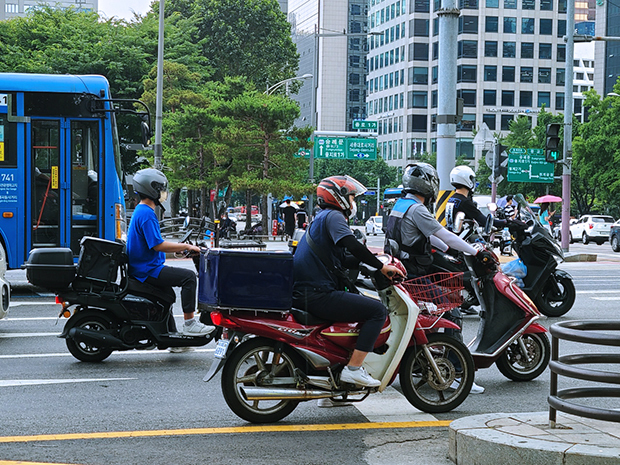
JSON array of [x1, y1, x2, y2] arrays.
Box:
[[0, 421, 451, 442]]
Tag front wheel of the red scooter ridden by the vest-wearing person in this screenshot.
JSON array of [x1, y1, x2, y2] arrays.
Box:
[[495, 333, 551, 381]]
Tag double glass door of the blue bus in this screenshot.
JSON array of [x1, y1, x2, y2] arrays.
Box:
[[30, 118, 101, 255]]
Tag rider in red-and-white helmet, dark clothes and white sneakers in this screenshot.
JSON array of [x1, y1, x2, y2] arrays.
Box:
[[293, 176, 402, 387]]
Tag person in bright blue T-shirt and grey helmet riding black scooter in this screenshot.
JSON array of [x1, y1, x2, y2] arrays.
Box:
[[127, 168, 215, 336]]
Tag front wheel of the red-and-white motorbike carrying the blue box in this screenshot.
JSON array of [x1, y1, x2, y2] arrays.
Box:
[[399, 333, 475, 413]]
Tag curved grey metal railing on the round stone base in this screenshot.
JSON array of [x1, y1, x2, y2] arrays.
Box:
[[547, 320, 620, 428]]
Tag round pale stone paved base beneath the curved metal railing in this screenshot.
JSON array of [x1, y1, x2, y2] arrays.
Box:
[[450, 412, 620, 465]]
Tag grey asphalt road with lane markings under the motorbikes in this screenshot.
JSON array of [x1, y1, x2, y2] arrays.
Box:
[[0, 236, 620, 465]]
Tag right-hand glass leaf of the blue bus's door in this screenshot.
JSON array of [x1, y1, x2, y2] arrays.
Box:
[[70, 121, 99, 250]]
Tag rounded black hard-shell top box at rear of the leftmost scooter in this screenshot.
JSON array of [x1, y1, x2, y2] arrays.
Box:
[[26, 247, 75, 291]]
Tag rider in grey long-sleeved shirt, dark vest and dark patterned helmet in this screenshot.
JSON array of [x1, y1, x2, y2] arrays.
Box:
[[385, 163, 493, 394]]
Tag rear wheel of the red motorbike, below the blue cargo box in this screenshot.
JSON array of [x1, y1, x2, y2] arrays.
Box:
[[222, 338, 302, 423]]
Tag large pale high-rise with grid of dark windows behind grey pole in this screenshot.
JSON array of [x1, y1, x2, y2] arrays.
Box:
[[367, 0, 566, 167]]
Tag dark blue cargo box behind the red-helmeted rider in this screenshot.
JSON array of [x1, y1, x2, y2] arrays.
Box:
[[198, 249, 293, 311]]
